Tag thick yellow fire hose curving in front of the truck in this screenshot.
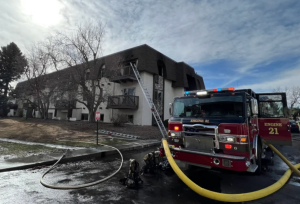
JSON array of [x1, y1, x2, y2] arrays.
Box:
[[162, 139, 300, 202]]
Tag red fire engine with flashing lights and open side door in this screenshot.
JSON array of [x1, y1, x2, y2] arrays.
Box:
[[160, 87, 292, 174]]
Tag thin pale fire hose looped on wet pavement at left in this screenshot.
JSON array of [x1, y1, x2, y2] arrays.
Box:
[[40, 143, 123, 190]]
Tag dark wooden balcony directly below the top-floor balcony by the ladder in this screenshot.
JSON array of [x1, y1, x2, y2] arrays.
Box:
[[107, 95, 139, 110]]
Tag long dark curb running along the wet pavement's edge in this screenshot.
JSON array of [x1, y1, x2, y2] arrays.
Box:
[[0, 141, 161, 172]]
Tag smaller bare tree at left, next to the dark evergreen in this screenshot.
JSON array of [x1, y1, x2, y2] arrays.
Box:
[[16, 43, 66, 119]]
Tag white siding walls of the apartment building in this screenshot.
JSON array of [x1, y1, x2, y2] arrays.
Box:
[[19, 72, 188, 125]]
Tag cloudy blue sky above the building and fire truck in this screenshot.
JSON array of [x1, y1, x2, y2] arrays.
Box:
[[0, 0, 300, 92]]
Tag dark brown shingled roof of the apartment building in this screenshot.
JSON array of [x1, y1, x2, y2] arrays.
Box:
[[17, 44, 205, 89]]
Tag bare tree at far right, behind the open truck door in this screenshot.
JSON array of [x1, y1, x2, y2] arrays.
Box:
[[274, 86, 300, 110]]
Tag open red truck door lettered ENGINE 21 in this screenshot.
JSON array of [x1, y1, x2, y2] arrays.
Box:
[[256, 93, 292, 146]]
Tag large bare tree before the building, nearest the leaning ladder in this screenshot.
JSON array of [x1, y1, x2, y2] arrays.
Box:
[[54, 23, 123, 122]]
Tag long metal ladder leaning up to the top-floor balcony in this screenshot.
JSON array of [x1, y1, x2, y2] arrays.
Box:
[[130, 60, 167, 138]]
